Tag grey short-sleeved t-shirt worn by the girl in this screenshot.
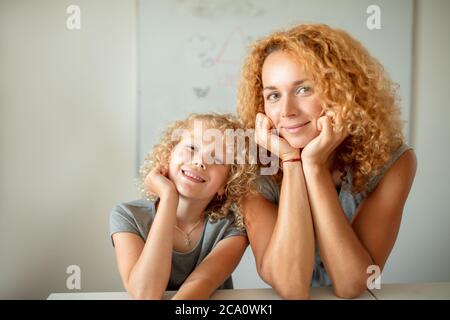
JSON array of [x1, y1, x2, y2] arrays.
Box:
[[110, 199, 246, 290]]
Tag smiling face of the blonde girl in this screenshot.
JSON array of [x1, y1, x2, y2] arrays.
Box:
[[169, 129, 230, 203]]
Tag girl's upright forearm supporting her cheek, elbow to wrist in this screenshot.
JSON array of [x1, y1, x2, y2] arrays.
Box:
[[128, 197, 178, 299]]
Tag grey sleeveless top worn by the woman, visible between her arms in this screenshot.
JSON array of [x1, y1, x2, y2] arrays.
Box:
[[256, 145, 411, 287]]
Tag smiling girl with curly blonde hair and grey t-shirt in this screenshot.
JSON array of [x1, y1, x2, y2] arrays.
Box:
[[110, 114, 257, 299]]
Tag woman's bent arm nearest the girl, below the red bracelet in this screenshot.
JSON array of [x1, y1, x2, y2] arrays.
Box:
[[243, 162, 314, 299]]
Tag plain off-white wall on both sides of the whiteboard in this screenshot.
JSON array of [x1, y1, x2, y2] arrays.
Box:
[[0, 0, 450, 298]]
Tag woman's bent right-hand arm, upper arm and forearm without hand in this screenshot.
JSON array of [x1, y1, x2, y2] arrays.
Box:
[[304, 151, 416, 298]]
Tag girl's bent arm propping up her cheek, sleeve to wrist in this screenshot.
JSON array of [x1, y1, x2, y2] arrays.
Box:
[[113, 192, 178, 299]]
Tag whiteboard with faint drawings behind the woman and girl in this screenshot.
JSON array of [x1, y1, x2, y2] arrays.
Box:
[[137, 0, 413, 288]]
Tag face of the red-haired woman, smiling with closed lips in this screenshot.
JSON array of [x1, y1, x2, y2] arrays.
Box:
[[262, 50, 322, 148]]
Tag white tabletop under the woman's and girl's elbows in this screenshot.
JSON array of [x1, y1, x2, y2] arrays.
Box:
[[47, 282, 450, 300]]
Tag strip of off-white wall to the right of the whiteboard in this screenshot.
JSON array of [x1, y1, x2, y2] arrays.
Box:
[[382, 0, 450, 282]]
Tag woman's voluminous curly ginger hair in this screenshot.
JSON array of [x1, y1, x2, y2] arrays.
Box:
[[238, 24, 404, 193]]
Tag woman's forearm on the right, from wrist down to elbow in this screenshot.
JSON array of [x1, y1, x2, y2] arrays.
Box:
[[304, 165, 373, 297]]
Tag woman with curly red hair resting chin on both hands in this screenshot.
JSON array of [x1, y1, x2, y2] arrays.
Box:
[[238, 24, 416, 299]]
